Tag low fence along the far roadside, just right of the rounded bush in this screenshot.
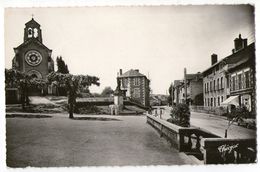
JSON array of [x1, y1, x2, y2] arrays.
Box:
[[190, 106, 227, 115]]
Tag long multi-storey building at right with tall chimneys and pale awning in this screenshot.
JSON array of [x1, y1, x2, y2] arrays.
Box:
[[202, 34, 255, 113]]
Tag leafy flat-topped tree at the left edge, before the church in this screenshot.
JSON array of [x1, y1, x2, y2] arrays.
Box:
[[5, 69, 47, 110]]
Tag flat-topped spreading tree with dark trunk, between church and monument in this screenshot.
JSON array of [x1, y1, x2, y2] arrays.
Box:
[[47, 72, 100, 118]]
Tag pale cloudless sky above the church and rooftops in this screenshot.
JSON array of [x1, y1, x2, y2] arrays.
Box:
[[4, 5, 254, 94]]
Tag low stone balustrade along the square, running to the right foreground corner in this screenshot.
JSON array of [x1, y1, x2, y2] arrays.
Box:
[[147, 114, 256, 164]]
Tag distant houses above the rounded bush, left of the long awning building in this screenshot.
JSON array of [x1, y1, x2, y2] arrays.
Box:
[[173, 72, 203, 105]]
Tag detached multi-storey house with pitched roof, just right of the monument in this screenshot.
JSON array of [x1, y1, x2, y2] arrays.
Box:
[[117, 69, 150, 106]]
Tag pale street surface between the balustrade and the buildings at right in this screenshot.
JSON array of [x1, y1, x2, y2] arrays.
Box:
[[158, 107, 256, 139]]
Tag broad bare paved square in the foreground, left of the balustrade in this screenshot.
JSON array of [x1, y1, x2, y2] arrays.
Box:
[[6, 114, 193, 167]]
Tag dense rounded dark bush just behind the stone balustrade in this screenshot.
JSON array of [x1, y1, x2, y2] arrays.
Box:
[[170, 104, 190, 127]]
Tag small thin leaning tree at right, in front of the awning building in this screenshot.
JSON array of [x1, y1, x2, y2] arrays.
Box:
[[225, 106, 250, 138]]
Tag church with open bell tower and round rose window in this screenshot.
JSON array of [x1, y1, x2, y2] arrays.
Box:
[[12, 18, 54, 95]]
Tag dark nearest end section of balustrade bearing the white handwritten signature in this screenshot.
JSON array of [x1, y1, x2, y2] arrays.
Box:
[[202, 138, 257, 164]]
